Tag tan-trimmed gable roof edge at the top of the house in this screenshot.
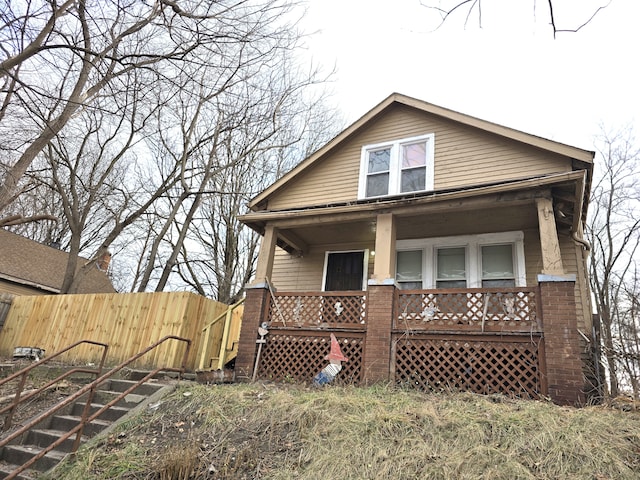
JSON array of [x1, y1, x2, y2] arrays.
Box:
[[249, 93, 594, 210]]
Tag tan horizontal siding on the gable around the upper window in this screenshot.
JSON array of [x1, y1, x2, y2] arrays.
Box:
[[268, 105, 571, 209]]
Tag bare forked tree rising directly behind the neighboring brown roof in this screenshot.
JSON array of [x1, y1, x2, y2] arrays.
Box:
[[43, 75, 157, 293]]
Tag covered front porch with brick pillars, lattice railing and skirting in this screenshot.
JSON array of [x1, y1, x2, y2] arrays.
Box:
[[236, 173, 584, 403]]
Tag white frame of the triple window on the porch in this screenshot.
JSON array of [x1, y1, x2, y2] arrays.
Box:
[[396, 231, 527, 289]]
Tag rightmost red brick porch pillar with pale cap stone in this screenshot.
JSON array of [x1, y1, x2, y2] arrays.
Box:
[[538, 275, 585, 405]]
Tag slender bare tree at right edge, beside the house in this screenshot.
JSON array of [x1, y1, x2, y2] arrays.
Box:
[[587, 126, 640, 397]]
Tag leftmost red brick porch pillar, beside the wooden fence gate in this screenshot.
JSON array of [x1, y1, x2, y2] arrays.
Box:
[[235, 286, 269, 382]]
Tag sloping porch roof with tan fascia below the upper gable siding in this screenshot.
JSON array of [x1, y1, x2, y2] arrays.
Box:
[[239, 170, 586, 252]]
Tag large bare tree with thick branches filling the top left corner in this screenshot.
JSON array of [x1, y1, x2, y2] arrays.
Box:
[[0, 0, 300, 215]]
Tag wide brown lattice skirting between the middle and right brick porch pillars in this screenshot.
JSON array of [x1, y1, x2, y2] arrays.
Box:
[[392, 334, 546, 398]]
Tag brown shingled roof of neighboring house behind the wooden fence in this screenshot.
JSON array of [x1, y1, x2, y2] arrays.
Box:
[[0, 228, 115, 293]]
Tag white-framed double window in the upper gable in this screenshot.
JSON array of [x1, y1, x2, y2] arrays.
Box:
[[358, 134, 434, 198]]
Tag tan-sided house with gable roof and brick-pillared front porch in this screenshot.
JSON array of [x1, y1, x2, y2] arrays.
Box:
[[236, 94, 594, 404]]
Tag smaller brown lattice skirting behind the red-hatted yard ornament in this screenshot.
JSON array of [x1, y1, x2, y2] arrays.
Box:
[[258, 329, 364, 385]]
